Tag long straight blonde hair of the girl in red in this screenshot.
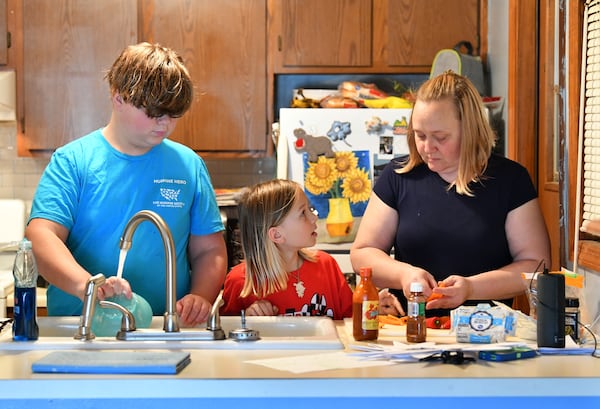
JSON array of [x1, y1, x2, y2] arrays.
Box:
[[238, 179, 315, 298]]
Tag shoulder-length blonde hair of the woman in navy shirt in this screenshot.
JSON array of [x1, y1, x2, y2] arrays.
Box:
[[396, 71, 496, 196]]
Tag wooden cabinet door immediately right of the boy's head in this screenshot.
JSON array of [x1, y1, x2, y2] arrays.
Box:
[[141, 0, 269, 155]]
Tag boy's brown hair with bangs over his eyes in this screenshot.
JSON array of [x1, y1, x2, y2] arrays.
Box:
[[105, 43, 194, 118]]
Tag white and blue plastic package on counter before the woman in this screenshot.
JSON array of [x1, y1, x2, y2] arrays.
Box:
[[452, 304, 516, 344]]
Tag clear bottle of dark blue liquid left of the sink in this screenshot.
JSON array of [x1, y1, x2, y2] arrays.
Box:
[[12, 239, 39, 341]]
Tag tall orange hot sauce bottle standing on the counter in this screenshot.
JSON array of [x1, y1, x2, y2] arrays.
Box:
[[352, 267, 379, 341]]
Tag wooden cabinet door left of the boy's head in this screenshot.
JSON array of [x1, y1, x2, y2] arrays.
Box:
[[19, 0, 137, 154]]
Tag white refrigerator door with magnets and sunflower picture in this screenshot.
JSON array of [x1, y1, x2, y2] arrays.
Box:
[[277, 108, 411, 243]]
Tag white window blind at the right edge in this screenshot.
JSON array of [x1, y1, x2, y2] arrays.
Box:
[[579, 0, 600, 237]]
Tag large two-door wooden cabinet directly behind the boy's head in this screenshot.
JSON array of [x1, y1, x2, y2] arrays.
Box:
[[15, 0, 270, 157]]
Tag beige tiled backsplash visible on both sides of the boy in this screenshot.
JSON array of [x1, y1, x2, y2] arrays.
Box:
[[0, 122, 276, 200]]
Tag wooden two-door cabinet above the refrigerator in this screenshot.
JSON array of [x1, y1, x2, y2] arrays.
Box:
[[268, 0, 487, 74]]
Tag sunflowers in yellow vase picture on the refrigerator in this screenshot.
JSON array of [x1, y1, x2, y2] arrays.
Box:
[[303, 150, 371, 243]]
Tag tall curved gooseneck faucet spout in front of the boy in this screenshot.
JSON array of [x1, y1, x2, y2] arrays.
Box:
[[120, 210, 179, 332]]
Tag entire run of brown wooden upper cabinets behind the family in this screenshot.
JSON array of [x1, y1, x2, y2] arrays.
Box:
[[11, 0, 478, 157]]
